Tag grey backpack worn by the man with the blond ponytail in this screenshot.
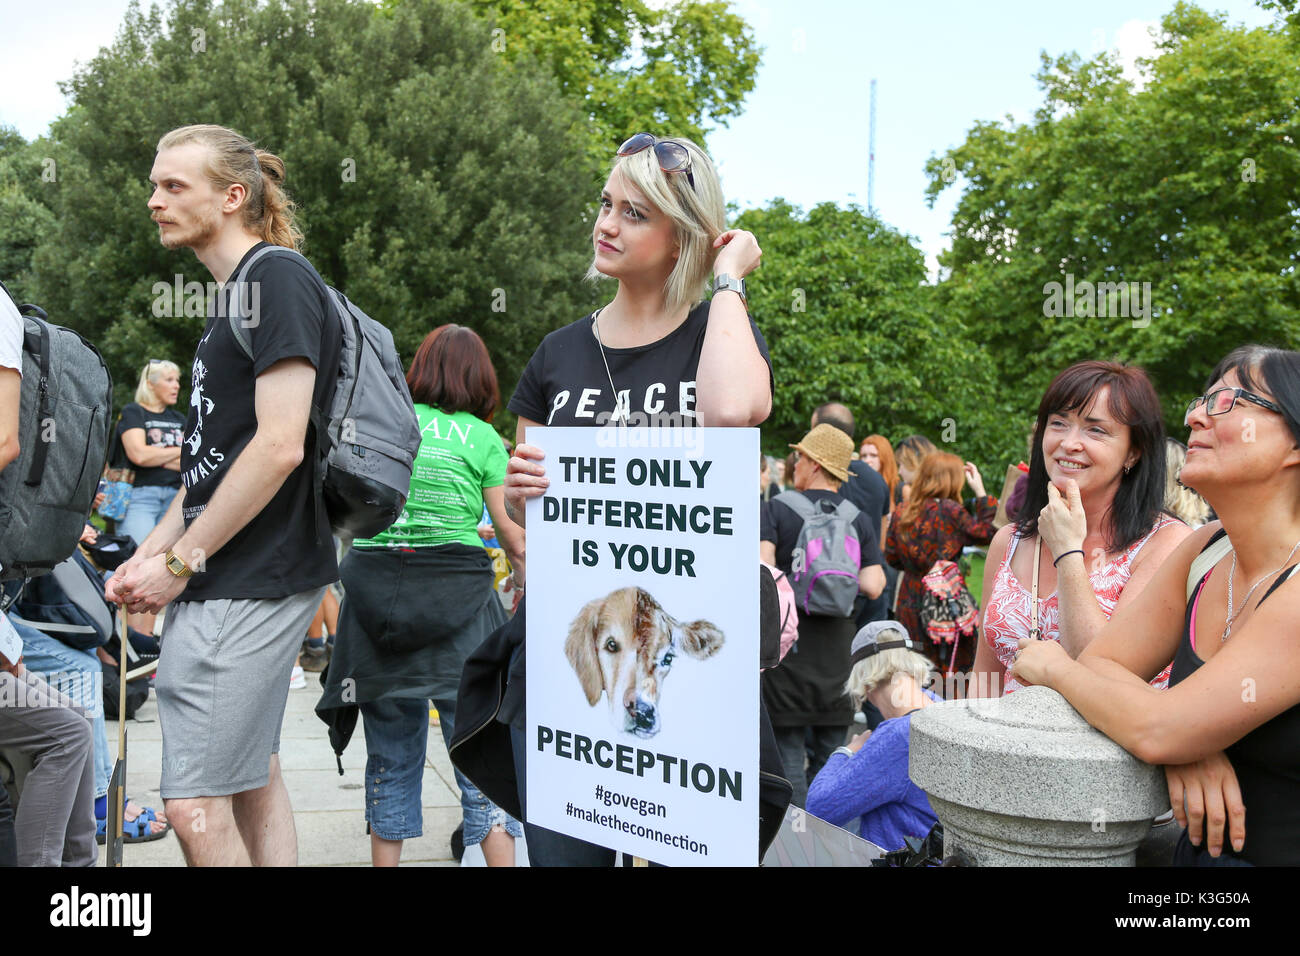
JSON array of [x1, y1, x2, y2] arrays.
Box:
[[229, 246, 420, 538]]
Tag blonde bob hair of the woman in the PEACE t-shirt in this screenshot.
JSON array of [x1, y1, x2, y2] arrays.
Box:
[[586, 137, 727, 313]]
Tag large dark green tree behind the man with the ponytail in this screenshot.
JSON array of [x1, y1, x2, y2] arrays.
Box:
[[21, 0, 595, 401]]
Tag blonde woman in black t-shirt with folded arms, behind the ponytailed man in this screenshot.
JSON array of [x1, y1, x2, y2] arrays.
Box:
[[117, 359, 185, 633]]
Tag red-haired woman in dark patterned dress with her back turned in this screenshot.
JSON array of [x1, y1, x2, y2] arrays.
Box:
[[885, 451, 997, 671]]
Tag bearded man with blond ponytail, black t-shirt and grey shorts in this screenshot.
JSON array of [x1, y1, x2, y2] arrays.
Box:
[[105, 126, 341, 866]]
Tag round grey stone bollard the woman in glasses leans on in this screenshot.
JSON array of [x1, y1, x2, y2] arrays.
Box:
[[909, 687, 1169, 866]]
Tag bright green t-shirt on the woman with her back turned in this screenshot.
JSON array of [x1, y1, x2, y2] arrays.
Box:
[[352, 403, 508, 548]]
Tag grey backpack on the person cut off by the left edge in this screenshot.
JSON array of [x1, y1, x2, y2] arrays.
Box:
[[0, 284, 113, 580]]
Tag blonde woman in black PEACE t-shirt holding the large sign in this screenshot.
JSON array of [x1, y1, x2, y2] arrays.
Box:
[[452, 133, 772, 865]]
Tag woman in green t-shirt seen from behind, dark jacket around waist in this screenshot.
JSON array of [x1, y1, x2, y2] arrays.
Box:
[[316, 325, 524, 866]]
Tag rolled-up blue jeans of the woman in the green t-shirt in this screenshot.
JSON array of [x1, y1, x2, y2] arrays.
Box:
[[361, 697, 524, 847]]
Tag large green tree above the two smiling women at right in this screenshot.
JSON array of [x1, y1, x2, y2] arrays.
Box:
[[927, 4, 1300, 431]]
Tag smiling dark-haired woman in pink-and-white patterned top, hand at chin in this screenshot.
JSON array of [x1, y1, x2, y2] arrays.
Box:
[[970, 362, 1188, 697]]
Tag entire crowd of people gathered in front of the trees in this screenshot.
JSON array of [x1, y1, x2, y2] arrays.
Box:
[[0, 119, 1300, 866]]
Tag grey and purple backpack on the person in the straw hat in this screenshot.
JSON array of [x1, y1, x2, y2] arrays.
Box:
[[772, 492, 862, 618]]
